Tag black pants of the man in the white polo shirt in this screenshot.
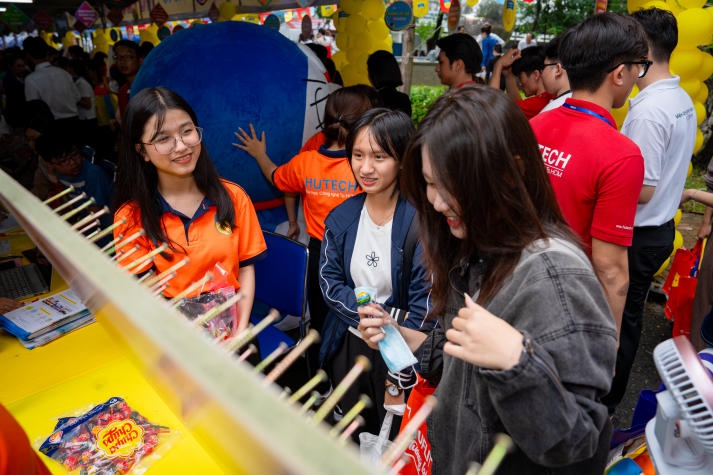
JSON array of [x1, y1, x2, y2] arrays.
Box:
[[602, 220, 675, 414]]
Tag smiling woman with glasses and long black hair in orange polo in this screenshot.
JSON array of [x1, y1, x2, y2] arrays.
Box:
[[114, 87, 266, 331]]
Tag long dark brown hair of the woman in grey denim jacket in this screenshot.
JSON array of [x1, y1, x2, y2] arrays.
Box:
[[402, 86, 577, 315]]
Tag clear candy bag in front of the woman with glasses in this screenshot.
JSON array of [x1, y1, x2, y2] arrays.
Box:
[[178, 264, 238, 340]]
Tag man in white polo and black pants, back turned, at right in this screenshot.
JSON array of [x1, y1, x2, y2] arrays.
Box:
[[602, 8, 696, 413]]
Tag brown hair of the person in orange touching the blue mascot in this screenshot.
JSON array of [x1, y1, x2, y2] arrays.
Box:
[[322, 84, 381, 147]]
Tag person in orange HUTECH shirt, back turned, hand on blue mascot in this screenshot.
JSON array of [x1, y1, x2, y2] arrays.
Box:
[[233, 85, 379, 338]]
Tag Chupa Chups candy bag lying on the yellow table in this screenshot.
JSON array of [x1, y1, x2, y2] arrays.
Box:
[[40, 397, 171, 475]]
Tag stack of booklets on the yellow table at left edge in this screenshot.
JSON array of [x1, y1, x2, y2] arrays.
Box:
[[0, 290, 95, 349]]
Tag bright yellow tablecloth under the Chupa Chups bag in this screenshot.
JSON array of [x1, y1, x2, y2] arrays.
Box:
[[0, 230, 224, 475]]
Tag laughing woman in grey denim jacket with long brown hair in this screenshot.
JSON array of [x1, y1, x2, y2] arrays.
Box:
[[359, 86, 617, 474]]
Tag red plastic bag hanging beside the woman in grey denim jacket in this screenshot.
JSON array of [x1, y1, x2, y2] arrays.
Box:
[[399, 376, 436, 475]]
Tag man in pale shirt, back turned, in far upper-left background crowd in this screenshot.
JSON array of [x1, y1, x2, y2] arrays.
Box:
[[22, 36, 81, 137]]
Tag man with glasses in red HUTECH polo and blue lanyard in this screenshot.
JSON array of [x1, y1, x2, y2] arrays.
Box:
[[530, 13, 648, 340]]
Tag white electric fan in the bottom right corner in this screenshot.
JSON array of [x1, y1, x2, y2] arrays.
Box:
[[646, 336, 713, 475]]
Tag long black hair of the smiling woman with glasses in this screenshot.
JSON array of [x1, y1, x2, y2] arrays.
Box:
[[114, 87, 235, 250]]
